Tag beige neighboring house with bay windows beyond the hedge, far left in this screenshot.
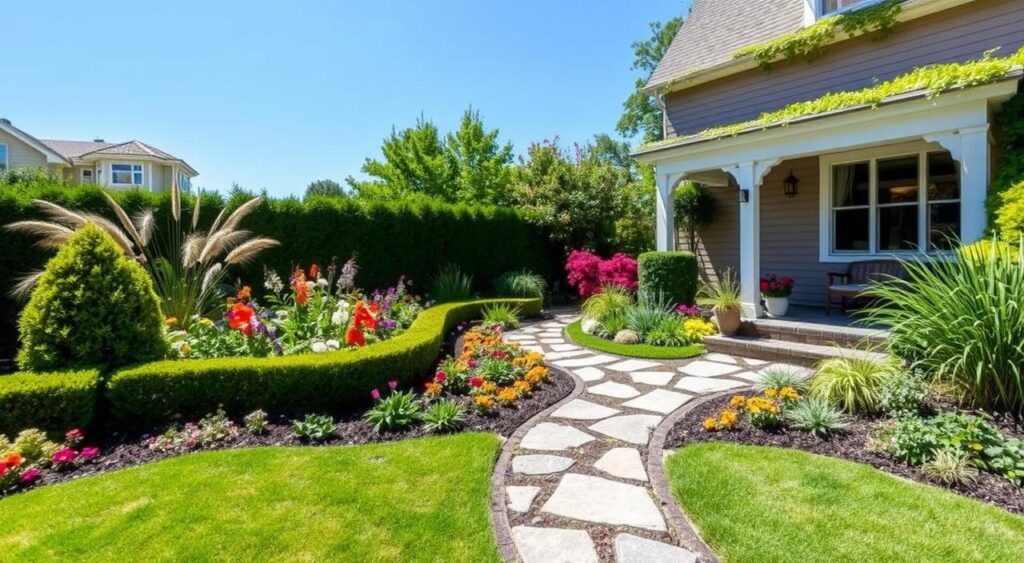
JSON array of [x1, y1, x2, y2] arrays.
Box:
[[0, 119, 199, 191]]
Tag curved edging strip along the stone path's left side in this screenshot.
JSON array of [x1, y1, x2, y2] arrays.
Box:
[[490, 363, 586, 562]]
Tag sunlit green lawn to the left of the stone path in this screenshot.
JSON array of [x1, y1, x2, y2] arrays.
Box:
[[0, 433, 500, 562]]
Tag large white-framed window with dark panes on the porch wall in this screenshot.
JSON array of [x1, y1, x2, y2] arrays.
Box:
[[828, 151, 961, 255]]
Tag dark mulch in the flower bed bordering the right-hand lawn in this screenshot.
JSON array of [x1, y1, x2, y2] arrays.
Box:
[[665, 396, 1024, 515]]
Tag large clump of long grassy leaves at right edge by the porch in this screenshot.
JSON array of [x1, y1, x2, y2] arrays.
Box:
[[868, 241, 1024, 414]]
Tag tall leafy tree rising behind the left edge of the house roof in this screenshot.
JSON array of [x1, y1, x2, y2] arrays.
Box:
[[615, 17, 683, 142]]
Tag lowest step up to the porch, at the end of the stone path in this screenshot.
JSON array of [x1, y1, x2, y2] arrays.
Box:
[[703, 335, 886, 367]]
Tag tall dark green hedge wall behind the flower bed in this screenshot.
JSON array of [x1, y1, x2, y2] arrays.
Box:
[[0, 187, 561, 358]]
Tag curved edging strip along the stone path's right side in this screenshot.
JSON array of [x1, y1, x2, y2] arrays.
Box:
[[647, 387, 749, 563]]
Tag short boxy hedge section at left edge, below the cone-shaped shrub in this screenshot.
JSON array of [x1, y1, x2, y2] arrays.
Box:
[[0, 370, 99, 436]]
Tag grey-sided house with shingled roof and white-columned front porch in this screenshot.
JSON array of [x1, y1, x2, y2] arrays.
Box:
[[635, 0, 1024, 316]]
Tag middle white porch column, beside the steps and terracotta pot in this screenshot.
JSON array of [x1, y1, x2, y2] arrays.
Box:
[[724, 160, 778, 318]]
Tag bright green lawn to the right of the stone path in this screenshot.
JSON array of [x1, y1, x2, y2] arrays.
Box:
[[666, 443, 1024, 563]]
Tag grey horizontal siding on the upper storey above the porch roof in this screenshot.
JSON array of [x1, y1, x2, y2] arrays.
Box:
[[666, 0, 1024, 136]]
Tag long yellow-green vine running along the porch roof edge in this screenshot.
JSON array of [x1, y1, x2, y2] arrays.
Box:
[[641, 47, 1024, 149]]
